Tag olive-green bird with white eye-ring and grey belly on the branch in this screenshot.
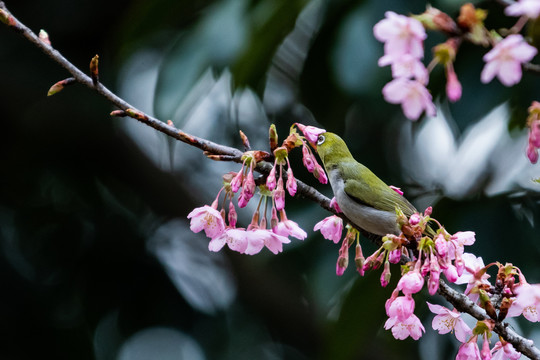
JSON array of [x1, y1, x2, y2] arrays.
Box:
[[316, 132, 417, 236]]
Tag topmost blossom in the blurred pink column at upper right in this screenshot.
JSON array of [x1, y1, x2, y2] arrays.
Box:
[[373, 11, 427, 59]]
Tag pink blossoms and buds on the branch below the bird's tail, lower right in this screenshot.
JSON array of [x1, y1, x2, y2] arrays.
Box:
[[315, 197, 540, 360]]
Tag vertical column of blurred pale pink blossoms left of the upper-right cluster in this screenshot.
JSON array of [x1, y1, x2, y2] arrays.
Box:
[[373, 11, 436, 120]]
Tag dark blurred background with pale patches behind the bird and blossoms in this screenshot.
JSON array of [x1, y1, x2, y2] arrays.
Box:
[[0, 0, 540, 360]]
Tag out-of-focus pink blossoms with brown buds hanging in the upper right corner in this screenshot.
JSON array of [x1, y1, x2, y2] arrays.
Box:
[[373, 0, 540, 124]]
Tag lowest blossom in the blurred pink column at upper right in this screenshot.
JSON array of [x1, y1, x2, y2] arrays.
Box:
[[382, 78, 437, 120]]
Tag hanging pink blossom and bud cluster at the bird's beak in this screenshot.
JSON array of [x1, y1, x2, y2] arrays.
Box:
[[188, 124, 327, 255]]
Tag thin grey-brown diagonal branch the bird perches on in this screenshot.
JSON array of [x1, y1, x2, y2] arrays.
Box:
[[0, 1, 540, 359]]
